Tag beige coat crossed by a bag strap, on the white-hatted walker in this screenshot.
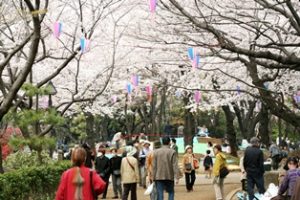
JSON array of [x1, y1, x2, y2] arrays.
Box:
[[121, 156, 140, 184]]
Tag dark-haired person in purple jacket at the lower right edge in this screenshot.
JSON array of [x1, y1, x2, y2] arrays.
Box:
[[278, 157, 300, 199]]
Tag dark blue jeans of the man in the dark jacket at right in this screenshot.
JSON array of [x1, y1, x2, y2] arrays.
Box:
[[247, 174, 265, 200]]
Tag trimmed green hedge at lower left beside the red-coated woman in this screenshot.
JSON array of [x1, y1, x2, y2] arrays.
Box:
[[0, 161, 71, 200]]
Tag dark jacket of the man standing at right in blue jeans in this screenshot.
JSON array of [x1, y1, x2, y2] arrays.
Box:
[[244, 146, 265, 177]]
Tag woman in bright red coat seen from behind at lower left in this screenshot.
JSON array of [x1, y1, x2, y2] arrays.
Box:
[[55, 147, 105, 200]]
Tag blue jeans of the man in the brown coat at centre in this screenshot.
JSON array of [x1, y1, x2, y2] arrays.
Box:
[[155, 180, 174, 200]]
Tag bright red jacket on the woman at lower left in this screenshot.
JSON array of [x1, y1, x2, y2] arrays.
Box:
[[55, 166, 105, 200]]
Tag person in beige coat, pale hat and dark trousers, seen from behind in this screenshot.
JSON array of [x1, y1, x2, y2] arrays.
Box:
[[121, 146, 140, 200]]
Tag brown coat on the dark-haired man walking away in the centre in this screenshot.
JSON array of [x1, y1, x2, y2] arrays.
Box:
[[152, 146, 179, 181]]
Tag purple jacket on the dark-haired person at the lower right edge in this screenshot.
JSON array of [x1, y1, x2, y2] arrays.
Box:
[[278, 169, 300, 196]]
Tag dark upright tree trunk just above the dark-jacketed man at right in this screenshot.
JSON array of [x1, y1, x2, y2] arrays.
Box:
[[259, 104, 270, 147]]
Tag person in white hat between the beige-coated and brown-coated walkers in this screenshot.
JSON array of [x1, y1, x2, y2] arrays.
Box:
[[139, 140, 151, 189]]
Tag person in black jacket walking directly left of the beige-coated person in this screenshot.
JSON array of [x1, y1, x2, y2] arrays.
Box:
[[110, 147, 122, 199]]
